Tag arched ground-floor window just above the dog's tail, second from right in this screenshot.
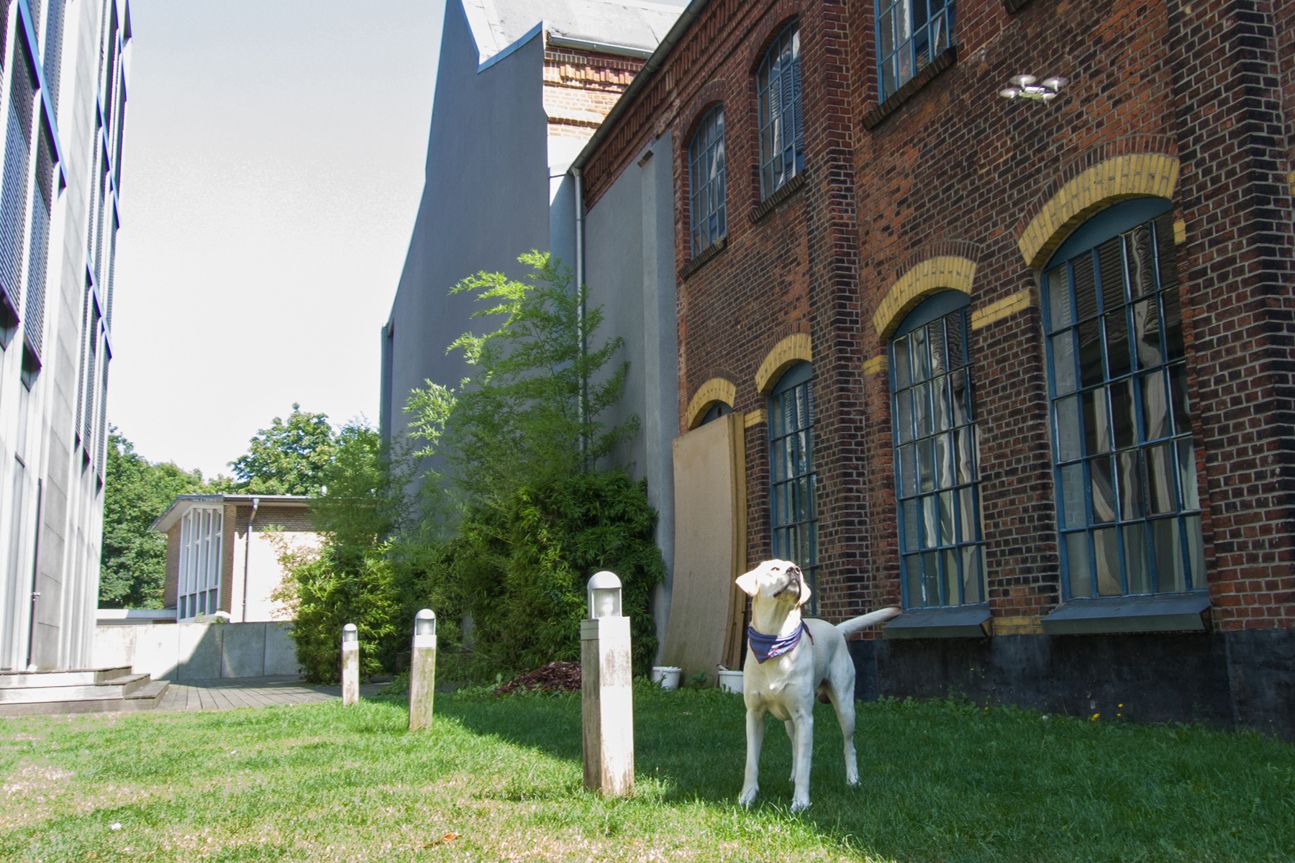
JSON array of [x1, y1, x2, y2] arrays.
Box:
[[890, 290, 985, 608]]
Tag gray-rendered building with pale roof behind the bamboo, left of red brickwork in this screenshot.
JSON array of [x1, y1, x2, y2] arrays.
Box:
[[379, 0, 684, 637]]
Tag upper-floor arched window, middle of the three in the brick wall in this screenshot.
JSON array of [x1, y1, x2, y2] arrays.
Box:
[[755, 22, 805, 198]]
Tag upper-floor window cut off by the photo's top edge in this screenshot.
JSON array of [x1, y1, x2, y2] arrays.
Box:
[[873, 0, 957, 102]]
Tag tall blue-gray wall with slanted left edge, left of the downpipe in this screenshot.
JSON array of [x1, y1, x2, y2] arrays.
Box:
[[379, 1, 549, 444]]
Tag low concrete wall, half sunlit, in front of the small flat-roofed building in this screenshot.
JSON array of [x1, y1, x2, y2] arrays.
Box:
[[95, 623, 300, 682]]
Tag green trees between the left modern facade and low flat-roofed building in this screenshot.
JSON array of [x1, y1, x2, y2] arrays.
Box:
[[98, 428, 207, 608]]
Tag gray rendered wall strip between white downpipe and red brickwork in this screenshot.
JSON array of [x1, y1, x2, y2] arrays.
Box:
[[584, 135, 679, 653]]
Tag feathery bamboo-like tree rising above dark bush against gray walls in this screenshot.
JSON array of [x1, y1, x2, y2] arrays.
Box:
[[405, 251, 637, 501]]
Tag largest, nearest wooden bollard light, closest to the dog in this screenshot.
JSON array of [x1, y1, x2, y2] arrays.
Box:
[[580, 571, 635, 797]]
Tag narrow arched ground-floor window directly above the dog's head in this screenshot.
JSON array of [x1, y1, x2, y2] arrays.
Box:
[[769, 363, 818, 599]]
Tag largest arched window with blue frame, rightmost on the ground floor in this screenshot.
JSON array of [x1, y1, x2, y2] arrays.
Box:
[[1042, 198, 1206, 599]]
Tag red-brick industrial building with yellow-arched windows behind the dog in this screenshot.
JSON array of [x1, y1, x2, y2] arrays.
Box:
[[574, 0, 1295, 735]]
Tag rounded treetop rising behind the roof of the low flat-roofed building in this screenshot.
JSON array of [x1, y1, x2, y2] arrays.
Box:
[[231, 402, 337, 496]]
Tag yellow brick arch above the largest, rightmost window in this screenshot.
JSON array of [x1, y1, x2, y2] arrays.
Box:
[[1017, 153, 1178, 270]]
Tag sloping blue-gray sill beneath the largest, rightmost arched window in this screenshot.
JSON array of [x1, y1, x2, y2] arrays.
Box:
[[1042, 592, 1210, 635]]
